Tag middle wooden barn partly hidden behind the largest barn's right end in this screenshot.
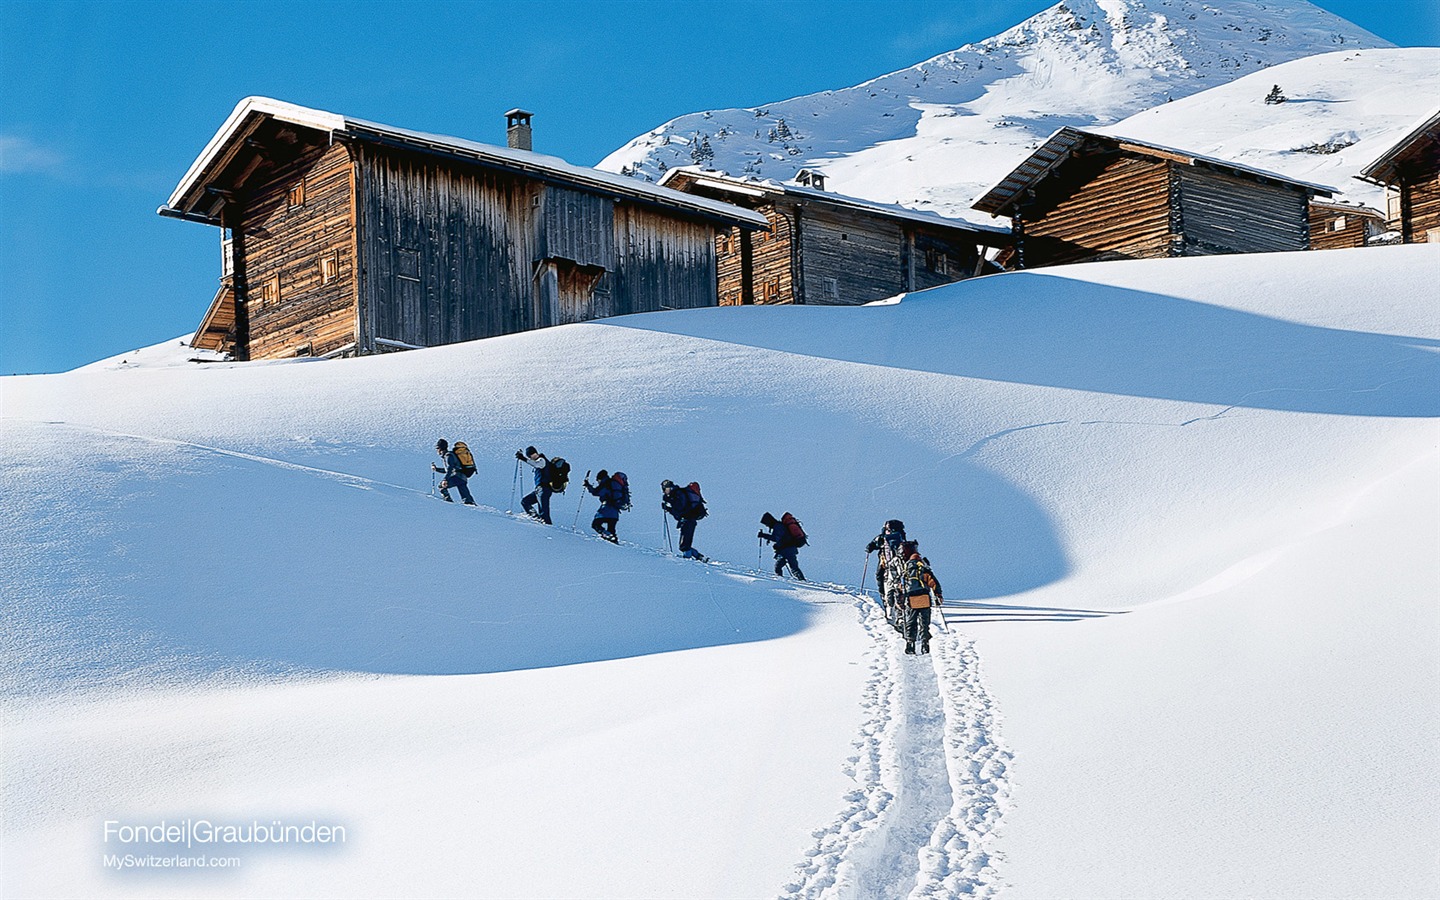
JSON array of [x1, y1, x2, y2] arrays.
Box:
[[660, 167, 1009, 305]]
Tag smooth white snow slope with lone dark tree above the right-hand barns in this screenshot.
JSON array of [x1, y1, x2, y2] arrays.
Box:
[[1102, 48, 1440, 212]]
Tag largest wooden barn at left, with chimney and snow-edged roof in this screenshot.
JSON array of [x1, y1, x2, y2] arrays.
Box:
[[160, 98, 769, 359]]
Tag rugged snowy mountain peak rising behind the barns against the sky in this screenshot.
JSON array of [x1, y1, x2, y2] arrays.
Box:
[[599, 0, 1391, 217]]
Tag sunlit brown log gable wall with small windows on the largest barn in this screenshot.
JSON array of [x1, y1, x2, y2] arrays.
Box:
[[235, 144, 359, 360]]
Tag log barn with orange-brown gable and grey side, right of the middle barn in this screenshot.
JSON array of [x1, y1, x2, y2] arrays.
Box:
[[973, 128, 1331, 268]]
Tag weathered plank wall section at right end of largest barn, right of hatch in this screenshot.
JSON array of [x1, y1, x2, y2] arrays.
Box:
[[603, 202, 717, 315]]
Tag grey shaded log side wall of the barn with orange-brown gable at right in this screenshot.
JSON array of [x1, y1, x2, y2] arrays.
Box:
[[1175, 166, 1310, 256]]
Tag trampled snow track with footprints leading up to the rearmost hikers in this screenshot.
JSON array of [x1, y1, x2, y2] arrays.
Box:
[[780, 598, 1011, 900]]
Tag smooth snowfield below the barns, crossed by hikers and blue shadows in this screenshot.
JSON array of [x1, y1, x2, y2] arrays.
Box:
[[0, 245, 1440, 897]]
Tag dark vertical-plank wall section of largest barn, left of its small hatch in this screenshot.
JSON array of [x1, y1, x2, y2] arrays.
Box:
[[360, 147, 541, 353]]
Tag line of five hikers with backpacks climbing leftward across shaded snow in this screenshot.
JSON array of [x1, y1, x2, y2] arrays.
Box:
[[431, 438, 808, 582]]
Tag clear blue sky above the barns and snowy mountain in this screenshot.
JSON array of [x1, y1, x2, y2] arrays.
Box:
[[0, 0, 1440, 374]]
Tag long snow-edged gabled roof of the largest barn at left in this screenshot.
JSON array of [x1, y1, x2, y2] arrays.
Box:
[[160, 96, 769, 228]]
